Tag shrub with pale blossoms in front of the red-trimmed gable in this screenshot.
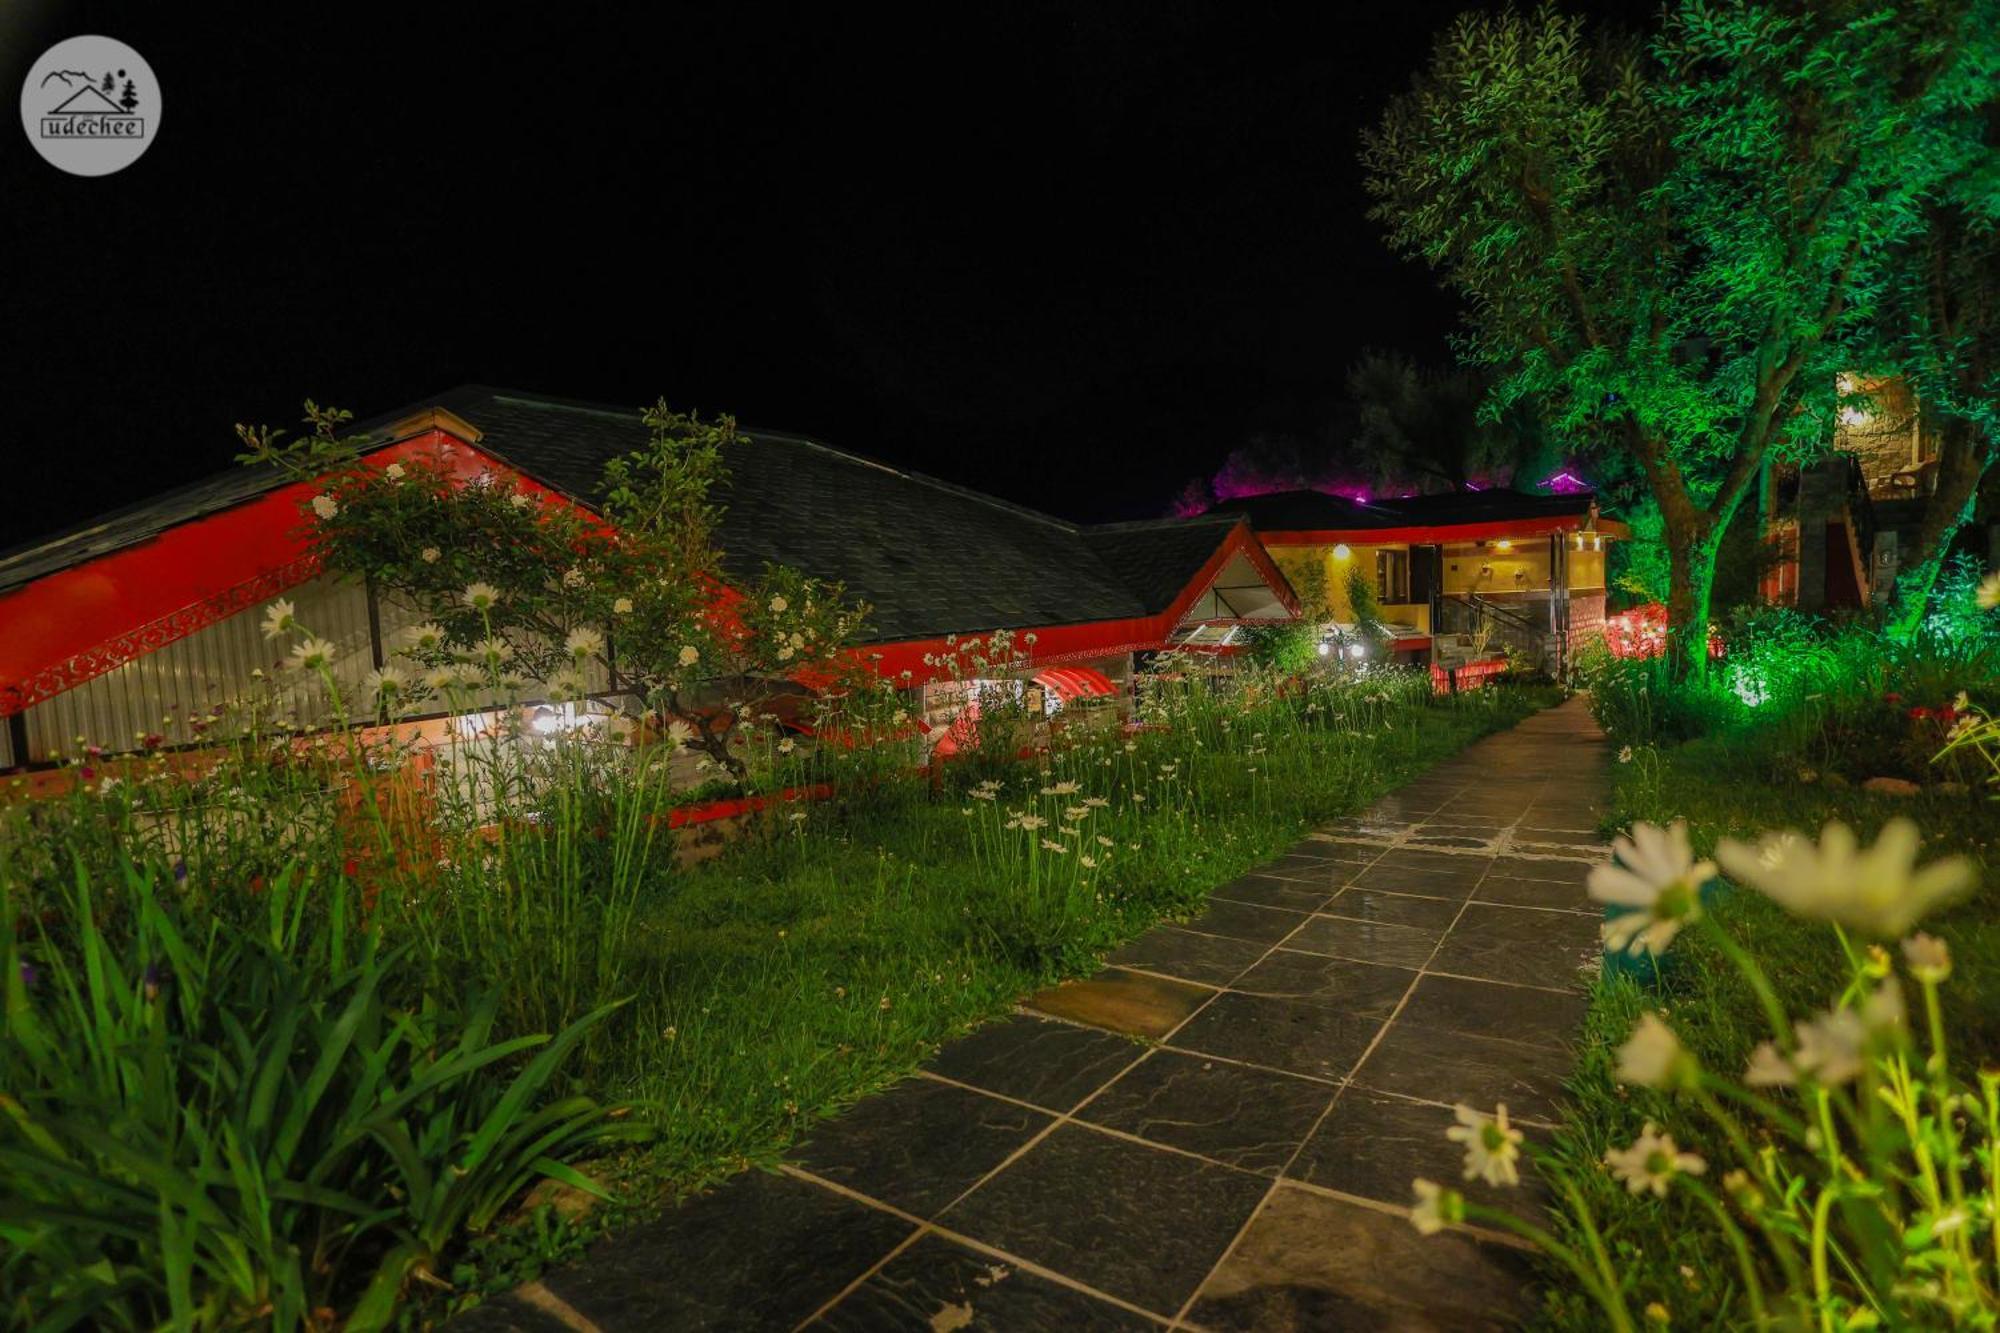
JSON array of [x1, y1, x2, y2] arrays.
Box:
[[238, 402, 866, 777]]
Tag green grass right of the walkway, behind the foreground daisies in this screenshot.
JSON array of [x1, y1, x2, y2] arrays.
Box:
[[1540, 737, 2000, 1329]]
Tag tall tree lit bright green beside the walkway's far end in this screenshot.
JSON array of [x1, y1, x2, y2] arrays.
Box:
[[1362, 0, 2000, 669]]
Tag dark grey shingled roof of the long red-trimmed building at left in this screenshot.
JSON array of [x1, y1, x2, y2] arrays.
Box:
[[0, 386, 1272, 640]]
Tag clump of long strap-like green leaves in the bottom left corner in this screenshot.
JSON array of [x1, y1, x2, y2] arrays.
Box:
[[0, 867, 646, 1329]]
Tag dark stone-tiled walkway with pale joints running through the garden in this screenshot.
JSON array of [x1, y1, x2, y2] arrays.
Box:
[[454, 701, 1608, 1333]]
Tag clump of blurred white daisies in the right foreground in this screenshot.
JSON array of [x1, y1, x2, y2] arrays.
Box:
[[1410, 821, 2000, 1329]]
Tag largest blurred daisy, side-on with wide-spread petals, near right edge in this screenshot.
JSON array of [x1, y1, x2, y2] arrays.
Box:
[[1716, 819, 1974, 939]]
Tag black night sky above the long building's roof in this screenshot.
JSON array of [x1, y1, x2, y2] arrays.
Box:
[[0, 0, 1512, 548]]
